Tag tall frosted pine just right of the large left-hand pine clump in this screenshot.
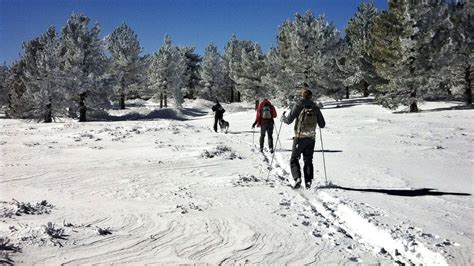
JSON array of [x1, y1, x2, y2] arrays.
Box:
[[107, 23, 146, 109]]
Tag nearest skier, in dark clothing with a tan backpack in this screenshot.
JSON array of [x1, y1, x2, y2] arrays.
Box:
[[281, 84, 326, 188]]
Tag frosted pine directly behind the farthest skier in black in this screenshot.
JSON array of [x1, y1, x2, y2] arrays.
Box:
[[199, 43, 226, 101]]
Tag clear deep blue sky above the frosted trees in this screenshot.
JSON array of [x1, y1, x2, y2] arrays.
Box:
[[0, 0, 387, 64]]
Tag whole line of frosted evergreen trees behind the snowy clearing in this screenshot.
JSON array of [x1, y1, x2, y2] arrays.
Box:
[[0, 0, 474, 122]]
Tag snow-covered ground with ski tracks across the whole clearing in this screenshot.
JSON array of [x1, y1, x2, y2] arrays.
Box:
[[0, 99, 474, 265]]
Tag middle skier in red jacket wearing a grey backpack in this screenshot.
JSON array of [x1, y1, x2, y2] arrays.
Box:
[[252, 99, 277, 153]]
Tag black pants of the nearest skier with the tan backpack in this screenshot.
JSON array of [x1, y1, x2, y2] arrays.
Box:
[[290, 138, 316, 183]]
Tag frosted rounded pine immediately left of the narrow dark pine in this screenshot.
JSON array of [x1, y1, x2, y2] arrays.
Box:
[[149, 35, 187, 108]]
